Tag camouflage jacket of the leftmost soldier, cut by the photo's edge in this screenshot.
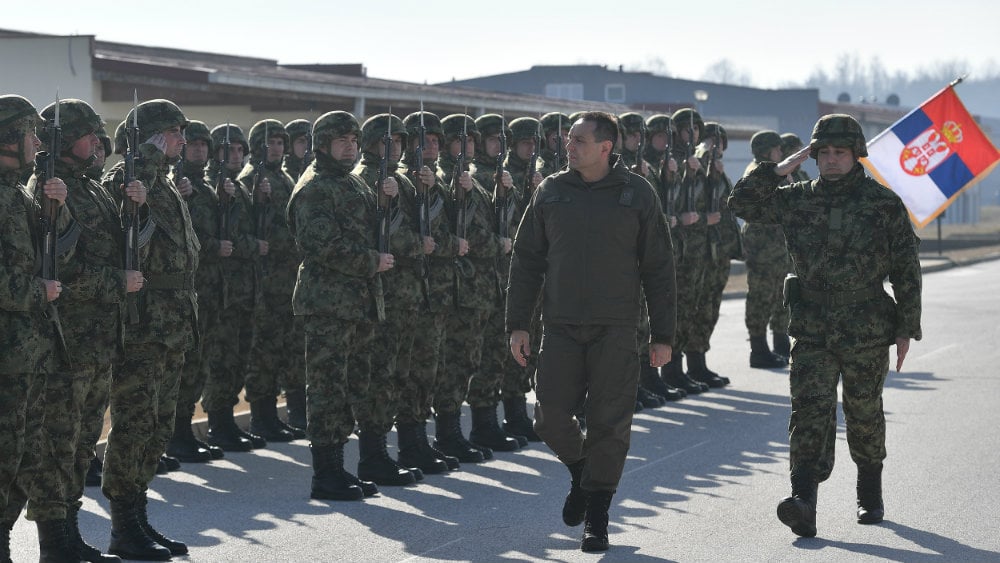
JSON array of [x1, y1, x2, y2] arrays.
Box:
[[0, 170, 59, 374]]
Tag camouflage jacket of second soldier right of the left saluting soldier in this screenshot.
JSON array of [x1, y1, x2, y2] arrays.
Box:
[[205, 160, 261, 310]]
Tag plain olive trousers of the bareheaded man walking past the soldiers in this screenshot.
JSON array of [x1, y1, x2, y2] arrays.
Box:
[[535, 325, 639, 491]]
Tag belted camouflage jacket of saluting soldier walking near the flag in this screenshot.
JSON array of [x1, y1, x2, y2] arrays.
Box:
[[729, 162, 921, 348]]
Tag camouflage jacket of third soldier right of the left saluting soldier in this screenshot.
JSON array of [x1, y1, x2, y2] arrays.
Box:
[[237, 159, 302, 302]]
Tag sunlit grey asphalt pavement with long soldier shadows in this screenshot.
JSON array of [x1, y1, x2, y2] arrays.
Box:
[[12, 260, 1000, 563]]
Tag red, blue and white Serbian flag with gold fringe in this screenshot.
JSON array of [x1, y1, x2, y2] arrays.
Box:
[[861, 81, 1000, 227]]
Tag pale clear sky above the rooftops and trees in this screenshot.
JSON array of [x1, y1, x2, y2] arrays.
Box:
[[0, 0, 1000, 87]]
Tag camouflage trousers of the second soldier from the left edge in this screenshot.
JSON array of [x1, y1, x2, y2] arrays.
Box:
[[3, 365, 111, 522]]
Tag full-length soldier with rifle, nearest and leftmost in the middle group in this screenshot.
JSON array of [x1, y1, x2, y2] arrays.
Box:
[[286, 111, 397, 500]]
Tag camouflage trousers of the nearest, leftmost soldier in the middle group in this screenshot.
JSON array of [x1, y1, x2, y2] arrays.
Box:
[[303, 315, 374, 446]]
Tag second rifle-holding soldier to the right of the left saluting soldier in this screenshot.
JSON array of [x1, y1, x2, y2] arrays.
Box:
[[201, 124, 271, 452]]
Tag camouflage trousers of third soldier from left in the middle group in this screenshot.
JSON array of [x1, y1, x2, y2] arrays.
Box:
[[396, 312, 445, 424]]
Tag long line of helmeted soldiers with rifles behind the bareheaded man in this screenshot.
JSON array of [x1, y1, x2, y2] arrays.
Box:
[[0, 89, 796, 561]]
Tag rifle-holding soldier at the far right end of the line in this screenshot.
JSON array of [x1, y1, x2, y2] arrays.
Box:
[[689, 122, 743, 381]]
